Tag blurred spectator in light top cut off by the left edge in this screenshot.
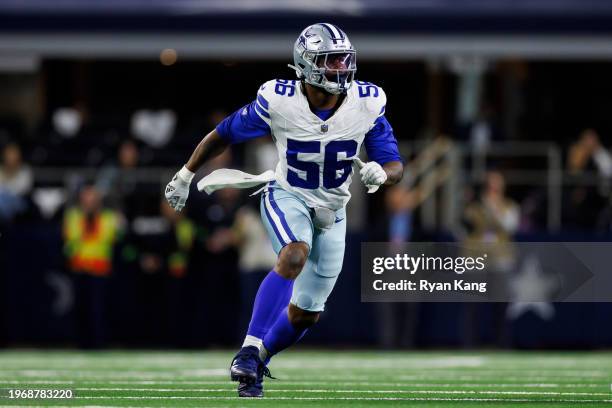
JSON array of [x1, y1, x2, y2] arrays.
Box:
[[0, 143, 34, 221]]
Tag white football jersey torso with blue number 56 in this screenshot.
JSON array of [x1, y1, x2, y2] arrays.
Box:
[[255, 79, 387, 210]]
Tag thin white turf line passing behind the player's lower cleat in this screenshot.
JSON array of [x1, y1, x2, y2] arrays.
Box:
[[67, 387, 610, 397]]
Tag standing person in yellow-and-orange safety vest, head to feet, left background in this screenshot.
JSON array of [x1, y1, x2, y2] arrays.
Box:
[[64, 186, 122, 348]]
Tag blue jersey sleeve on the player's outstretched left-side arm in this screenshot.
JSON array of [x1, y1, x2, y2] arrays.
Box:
[[217, 95, 272, 144]]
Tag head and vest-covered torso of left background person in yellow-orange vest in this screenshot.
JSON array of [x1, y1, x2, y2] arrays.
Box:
[[64, 186, 121, 276]]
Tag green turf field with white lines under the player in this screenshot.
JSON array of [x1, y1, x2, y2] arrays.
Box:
[[0, 351, 612, 408]]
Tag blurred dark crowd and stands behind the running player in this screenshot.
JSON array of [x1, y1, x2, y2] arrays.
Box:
[[0, 56, 612, 348]]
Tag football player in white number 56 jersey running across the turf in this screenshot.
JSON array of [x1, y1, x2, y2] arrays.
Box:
[[166, 23, 403, 397]]
